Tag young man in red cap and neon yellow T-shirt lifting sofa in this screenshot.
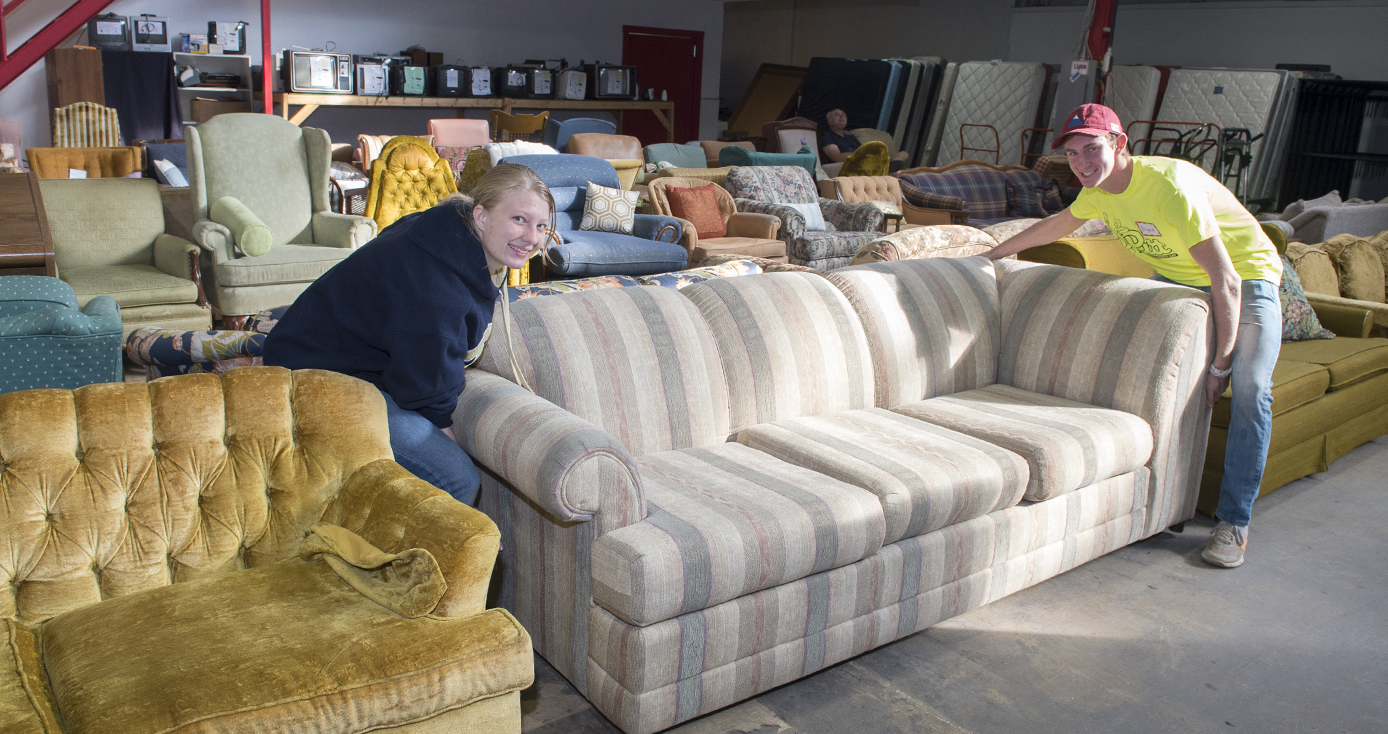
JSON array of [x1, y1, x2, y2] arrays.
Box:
[[988, 104, 1283, 569]]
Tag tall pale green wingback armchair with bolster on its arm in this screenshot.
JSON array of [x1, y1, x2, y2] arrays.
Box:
[[186, 112, 376, 318]]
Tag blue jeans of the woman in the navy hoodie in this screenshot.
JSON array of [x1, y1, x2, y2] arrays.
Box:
[[380, 390, 482, 505]]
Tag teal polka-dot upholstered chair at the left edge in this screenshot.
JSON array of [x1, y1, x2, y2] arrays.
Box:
[[0, 275, 122, 393]]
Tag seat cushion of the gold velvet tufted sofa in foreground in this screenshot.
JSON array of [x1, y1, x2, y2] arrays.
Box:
[[43, 559, 532, 734]]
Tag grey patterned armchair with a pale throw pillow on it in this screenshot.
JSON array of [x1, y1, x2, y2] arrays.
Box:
[[727, 165, 883, 271]]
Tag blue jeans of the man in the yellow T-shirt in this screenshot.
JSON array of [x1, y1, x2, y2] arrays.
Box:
[[1152, 275, 1283, 526]]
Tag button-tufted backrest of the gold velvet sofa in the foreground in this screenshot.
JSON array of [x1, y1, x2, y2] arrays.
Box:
[[0, 368, 393, 624]]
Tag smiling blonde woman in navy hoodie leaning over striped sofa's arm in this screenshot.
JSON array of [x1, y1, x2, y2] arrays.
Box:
[[265, 164, 554, 505]]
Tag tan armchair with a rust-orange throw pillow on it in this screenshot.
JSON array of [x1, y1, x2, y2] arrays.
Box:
[[650, 176, 787, 268]]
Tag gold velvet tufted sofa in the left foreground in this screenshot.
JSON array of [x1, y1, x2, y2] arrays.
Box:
[[0, 368, 533, 734]]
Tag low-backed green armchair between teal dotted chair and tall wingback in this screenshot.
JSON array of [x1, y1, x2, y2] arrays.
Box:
[[39, 179, 212, 339]]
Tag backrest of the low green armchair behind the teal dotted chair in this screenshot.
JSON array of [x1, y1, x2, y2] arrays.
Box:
[[39, 179, 164, 273]]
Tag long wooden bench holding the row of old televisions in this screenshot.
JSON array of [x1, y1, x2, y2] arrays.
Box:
[[275, 93, 675, 143]]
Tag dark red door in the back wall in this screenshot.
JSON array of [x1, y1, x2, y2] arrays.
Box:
[[622, 25, 704, 146]]
